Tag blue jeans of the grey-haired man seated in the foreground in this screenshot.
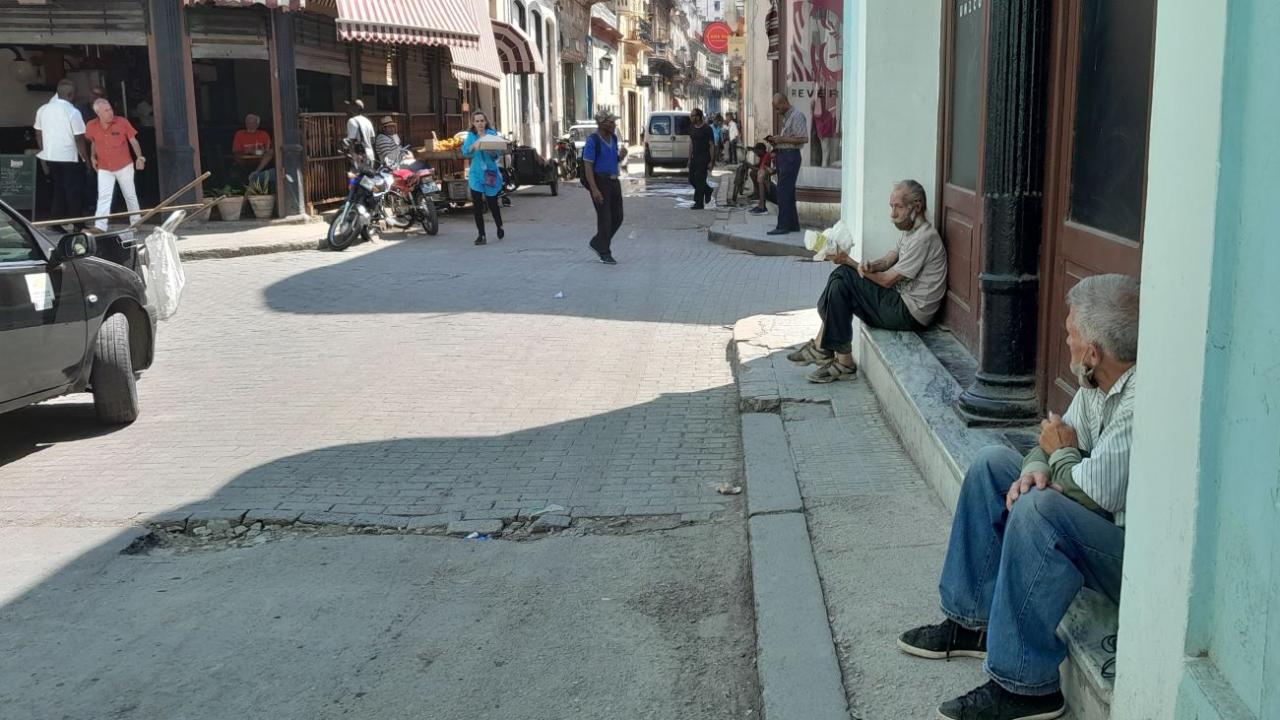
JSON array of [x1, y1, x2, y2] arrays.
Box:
[[938, 447, 1124, 694]]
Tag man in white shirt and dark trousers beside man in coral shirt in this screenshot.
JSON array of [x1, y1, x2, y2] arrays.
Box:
[[35, 78, 88, 226]]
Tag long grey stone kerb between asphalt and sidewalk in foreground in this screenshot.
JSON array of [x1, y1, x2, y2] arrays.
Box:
[[730, 326, 849, 720]]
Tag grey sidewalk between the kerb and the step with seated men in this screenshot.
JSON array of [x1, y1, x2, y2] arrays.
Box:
[[733, 310, 1054, 720]]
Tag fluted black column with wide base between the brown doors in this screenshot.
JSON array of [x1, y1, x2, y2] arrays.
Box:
[[957, 0, 1051, 424]]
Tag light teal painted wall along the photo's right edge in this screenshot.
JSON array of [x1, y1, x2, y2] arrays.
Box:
[[1177, 0, 1280, 719]]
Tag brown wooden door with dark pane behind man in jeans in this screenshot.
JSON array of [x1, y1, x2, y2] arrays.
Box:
[[1039, 0, 1156, 413]]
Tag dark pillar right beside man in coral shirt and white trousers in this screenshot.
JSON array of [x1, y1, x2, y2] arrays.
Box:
[[147, 0, 196, 202]]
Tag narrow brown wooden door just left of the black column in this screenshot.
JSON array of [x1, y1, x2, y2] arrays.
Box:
[[937, 0, 989, 352]]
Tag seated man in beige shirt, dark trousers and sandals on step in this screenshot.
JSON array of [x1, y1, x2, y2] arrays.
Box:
[[787, 179, 947, 383]]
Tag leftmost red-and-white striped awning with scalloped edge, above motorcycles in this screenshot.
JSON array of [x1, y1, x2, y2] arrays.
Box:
[[337, 0, 489, 49]]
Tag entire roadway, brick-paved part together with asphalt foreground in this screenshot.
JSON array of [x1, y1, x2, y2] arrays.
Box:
[[0, 177, 824, 720]]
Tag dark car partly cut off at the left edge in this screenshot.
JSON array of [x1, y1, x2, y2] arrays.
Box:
[[0, 197, 156, 423]]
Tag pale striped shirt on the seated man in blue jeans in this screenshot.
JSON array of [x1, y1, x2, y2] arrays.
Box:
[[1023, 366, 1138, 528]]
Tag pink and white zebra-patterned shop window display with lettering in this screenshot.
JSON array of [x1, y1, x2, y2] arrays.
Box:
[[787, 0, 845, 168]]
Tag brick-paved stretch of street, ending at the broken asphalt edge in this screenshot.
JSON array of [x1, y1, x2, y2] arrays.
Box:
[[0, 176, 824, 525]]
